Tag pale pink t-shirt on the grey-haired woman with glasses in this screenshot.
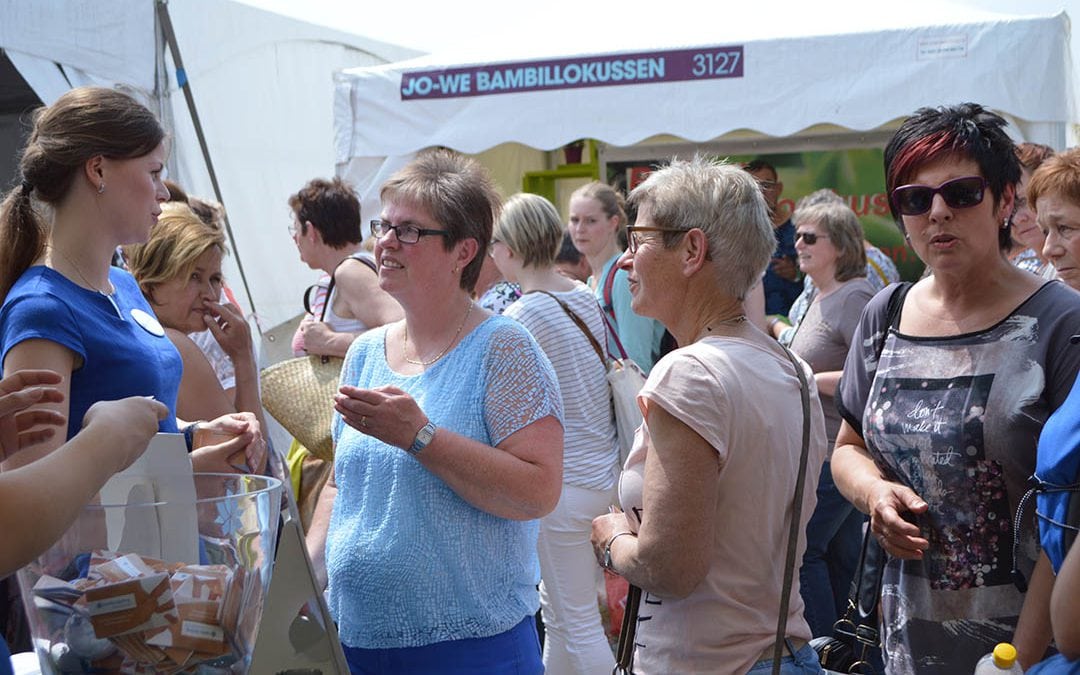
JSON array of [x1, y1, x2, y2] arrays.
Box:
[[619, 337, 826, 675]]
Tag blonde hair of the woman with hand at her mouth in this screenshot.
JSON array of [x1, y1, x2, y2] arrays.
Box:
[[124, 202, 228, 298]]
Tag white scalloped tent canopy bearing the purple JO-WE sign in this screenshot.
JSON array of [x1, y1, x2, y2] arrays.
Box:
[[335, 5, 1075, 213]]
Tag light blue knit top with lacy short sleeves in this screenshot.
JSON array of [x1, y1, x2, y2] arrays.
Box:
[[326, 316, 562, 649]]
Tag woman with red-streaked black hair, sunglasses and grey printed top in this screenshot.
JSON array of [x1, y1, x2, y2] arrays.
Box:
[[833, 104, 1080, 675]]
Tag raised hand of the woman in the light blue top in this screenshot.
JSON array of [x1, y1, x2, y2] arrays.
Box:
[[334, 384, 428, 448]]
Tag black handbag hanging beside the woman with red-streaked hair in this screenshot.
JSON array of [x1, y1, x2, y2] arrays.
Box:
[[810, 527, 886, 675]]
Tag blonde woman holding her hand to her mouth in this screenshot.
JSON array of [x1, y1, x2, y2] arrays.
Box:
[[124, 202, 262, 432]]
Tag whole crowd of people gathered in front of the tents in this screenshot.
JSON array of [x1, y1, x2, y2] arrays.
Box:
[[0, 87, 1080, 675]]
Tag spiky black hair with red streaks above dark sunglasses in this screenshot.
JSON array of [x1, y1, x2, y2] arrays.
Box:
[[885, 103, 1021, 251]]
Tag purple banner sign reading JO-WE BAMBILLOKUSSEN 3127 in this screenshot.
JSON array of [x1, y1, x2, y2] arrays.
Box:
[[401, 45, 743, 100]]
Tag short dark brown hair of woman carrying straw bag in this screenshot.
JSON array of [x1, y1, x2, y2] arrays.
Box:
[[288, 177, 364, 248]]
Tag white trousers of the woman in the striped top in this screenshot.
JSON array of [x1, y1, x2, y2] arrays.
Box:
[[537, 484, 615, 675]]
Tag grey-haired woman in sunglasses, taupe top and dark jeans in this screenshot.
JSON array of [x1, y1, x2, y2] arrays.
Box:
[[773, 203, 874, 637]]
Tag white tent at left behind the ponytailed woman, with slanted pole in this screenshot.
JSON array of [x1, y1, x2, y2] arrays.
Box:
[[0, 0, 417, 328]]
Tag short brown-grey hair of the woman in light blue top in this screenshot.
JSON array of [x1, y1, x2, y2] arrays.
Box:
[[379, 148, 500, 293]]
